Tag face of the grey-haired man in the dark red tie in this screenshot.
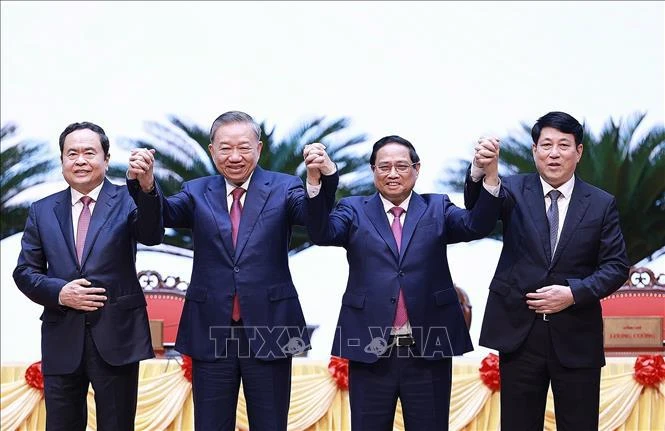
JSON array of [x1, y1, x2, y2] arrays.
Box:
[[208, 123, 263, 186]]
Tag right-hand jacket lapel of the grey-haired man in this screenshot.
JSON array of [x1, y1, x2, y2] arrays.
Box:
[[235, 166, 272, 260]]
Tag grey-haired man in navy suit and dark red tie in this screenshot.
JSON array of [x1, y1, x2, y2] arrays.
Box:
[[128, 111, 338, 431]]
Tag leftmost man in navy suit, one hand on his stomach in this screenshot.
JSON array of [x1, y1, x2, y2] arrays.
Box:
[[14, 122, 164, 431]]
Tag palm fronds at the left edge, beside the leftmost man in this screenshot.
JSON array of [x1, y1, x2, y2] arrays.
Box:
[[0, 123, 58, 238]]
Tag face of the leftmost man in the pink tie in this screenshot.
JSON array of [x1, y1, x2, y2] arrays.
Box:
[[62, 129, 109, 194]]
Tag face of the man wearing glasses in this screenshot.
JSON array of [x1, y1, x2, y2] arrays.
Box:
[[373, 144, 420, 205]]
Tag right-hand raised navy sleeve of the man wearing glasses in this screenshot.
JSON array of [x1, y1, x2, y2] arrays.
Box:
[[444, 186, 505, 244]]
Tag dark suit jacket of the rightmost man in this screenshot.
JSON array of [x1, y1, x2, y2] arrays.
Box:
[[465, 173, 629, 368]]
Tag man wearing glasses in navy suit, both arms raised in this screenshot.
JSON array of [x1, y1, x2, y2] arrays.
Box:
[[305, 136, 503, 431]]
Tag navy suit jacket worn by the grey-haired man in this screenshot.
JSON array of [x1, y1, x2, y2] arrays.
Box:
[[128, 167, 339, 361]]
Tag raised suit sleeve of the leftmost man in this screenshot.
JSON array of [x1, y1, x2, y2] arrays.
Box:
[[130, 181, 164, 245]]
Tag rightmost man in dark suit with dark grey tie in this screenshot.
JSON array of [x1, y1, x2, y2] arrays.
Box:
[[465, 112, 628, 431]]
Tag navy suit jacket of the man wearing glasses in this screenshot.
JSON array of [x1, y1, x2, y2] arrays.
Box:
[[307, 186, 502, 363]]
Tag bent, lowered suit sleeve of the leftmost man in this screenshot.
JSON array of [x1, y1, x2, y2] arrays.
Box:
[[13, 205, 67, 308]]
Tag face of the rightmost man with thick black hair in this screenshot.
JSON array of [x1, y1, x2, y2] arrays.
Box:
[[531, 127, 582, 188]]
